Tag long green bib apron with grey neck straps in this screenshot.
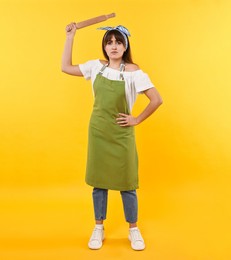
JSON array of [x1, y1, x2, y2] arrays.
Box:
[[86, 65, 138, 191]]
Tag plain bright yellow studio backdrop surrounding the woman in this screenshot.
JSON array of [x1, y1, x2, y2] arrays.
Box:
[[0, 0, 231, 260]]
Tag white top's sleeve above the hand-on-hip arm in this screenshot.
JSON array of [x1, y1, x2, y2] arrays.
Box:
[[133, 70, 155, 94]]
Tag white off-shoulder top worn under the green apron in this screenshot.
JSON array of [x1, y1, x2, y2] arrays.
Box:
[[79, 59, 154, 111]]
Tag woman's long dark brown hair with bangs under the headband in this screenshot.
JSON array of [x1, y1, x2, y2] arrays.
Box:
[[102, 30, 133, 63]]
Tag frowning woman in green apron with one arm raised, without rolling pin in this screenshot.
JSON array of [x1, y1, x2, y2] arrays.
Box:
[[62, 23, 162, 250]]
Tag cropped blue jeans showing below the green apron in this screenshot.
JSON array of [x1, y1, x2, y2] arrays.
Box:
[[92, 188, 138, 223]]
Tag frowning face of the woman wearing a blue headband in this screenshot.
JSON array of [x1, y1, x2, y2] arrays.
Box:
[[104, 35, 126, 59]]
